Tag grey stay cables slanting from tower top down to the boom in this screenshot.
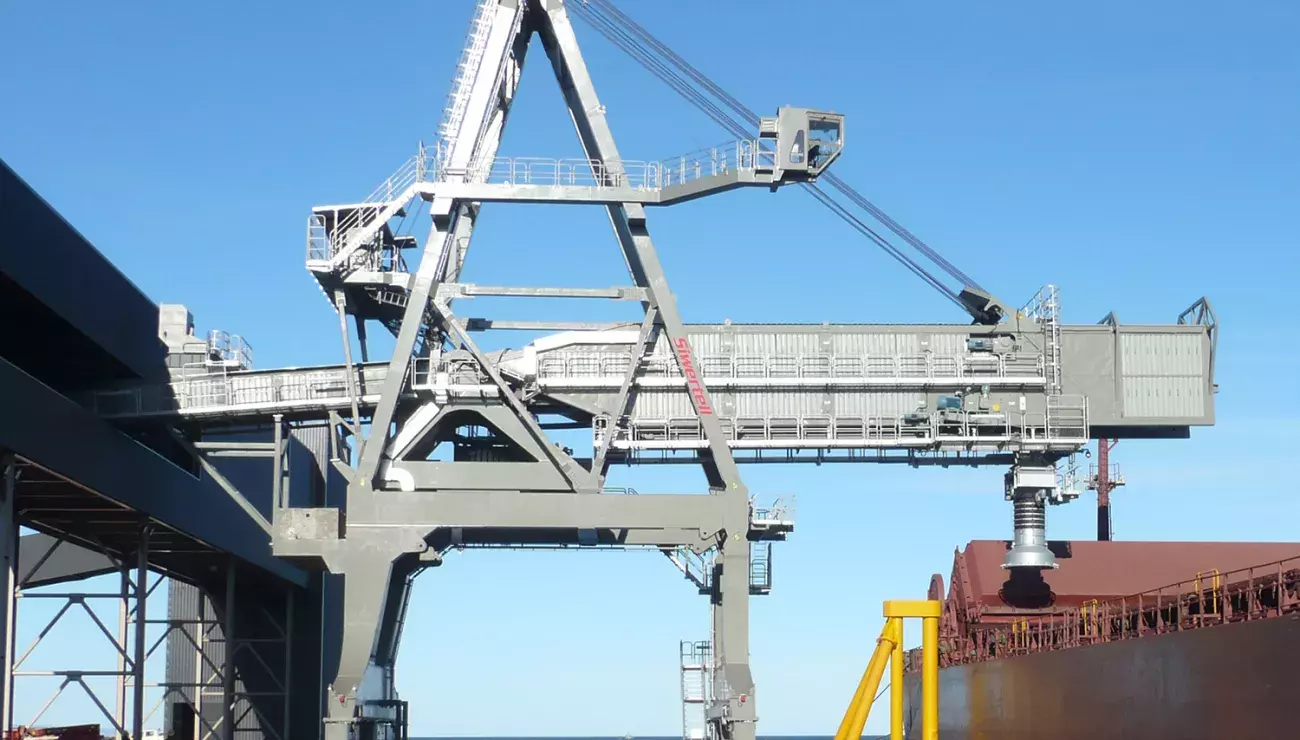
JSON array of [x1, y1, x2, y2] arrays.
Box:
[[571, 0, 980, 297]]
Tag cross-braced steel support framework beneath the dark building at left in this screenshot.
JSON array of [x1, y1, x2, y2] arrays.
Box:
[[0, 455, 294, 740]]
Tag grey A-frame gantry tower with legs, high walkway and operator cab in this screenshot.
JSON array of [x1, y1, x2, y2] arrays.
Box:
[[274, 0, 844, 740]]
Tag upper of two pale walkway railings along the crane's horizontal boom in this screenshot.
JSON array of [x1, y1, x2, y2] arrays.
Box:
[[537, 352, 1045, 381]]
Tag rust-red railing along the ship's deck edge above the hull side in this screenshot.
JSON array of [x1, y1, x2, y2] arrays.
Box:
[[943, 555, 1300, 665]]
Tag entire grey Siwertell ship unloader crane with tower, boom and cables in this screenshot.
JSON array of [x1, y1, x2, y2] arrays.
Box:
[[78, 0, 1217, 740]]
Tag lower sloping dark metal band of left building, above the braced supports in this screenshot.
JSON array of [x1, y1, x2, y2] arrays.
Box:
[[0, 359, 306, 583]]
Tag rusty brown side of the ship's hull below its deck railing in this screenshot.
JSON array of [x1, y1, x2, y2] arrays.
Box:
[[906, 615, 1300, 740]]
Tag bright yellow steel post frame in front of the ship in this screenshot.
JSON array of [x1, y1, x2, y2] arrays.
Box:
[[835, 601, 943, 740]]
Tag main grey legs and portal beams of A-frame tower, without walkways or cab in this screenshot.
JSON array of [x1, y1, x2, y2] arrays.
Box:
[[274, 0, 780, 740]]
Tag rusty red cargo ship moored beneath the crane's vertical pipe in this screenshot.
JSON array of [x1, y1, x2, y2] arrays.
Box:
[[905, 542, 1300, 740]]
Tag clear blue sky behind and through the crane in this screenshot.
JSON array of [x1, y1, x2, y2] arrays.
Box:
[[0, 0, 1300, 735]]
